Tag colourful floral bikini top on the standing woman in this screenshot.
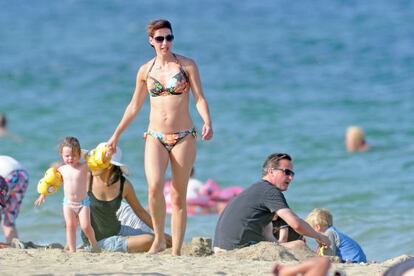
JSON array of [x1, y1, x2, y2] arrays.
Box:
[[147, 54, 190, 97]]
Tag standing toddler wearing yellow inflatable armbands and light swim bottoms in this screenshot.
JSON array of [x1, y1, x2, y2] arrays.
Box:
[[35, 137, 110, 252]]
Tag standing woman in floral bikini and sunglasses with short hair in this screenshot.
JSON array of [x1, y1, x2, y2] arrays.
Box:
[[108, 20, 213, 255]]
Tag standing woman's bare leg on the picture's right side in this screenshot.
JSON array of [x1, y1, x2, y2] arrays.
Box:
[[171, 135, 196, 256]]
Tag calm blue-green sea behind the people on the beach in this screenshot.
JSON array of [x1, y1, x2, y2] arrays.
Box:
[[0, 0, 414, 261]]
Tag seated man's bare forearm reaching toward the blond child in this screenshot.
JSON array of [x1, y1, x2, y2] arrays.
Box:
[[276, 208, 331, 246]]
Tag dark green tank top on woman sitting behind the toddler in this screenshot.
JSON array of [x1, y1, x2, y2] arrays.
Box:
[[82, 175, 125, 243]]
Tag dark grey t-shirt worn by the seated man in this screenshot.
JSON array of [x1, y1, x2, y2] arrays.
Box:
[[214, 180, 289, 250]]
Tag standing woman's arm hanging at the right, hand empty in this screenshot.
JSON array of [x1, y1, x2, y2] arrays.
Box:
[[185, 59, 213, 140]]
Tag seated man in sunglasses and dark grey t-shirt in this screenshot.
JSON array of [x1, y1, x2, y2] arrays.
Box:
[[214, 153, 330, 252]]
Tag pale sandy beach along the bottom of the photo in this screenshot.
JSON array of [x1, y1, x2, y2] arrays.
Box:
[[0, 239, 409, 276]]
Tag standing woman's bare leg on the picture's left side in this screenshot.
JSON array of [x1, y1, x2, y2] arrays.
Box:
[[144, 135, 169, 253]]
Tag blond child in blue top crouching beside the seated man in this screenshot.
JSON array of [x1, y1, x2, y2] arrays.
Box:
[[306, 208, 367, 263]]
